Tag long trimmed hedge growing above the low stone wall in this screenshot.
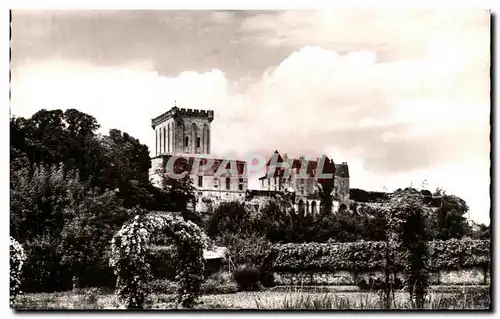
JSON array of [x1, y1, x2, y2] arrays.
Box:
[[269, 238, 490, 272]]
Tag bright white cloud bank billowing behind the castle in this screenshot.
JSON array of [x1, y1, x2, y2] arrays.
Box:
[[11, 13, 490, 222]]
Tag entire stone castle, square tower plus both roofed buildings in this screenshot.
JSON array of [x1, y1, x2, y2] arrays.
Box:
[[150, 106, 349, 218]]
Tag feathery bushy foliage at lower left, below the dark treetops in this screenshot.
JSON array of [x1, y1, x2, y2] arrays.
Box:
[[10, 165, 130, 291]]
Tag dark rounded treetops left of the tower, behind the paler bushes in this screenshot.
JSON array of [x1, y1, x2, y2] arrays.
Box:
[[10, 109, 156, 212]]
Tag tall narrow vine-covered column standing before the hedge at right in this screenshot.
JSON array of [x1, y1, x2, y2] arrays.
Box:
[[387, 191, 429, 308]]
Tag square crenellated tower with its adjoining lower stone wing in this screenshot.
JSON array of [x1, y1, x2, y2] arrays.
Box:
[[150, 106, 248, 215]]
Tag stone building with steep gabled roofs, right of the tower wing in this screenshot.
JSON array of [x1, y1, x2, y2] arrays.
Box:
[[259, 150, 349, 215]]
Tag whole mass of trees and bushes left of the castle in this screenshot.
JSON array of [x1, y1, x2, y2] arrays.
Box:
[[10, 109, 188, 291]]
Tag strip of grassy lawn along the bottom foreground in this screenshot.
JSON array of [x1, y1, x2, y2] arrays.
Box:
[[13, 289, 489, 309]]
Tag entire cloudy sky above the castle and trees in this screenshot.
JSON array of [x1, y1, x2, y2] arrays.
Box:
[[11, 8, 490, 223]]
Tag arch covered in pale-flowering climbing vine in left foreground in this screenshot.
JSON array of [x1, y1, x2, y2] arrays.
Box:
[[110, 209, 209, 309]]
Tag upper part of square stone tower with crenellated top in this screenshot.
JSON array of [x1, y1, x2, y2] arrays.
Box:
[[151, 106, 214, 156]]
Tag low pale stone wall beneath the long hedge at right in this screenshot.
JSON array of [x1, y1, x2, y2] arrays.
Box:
[[274, 268, 490, 286]]
